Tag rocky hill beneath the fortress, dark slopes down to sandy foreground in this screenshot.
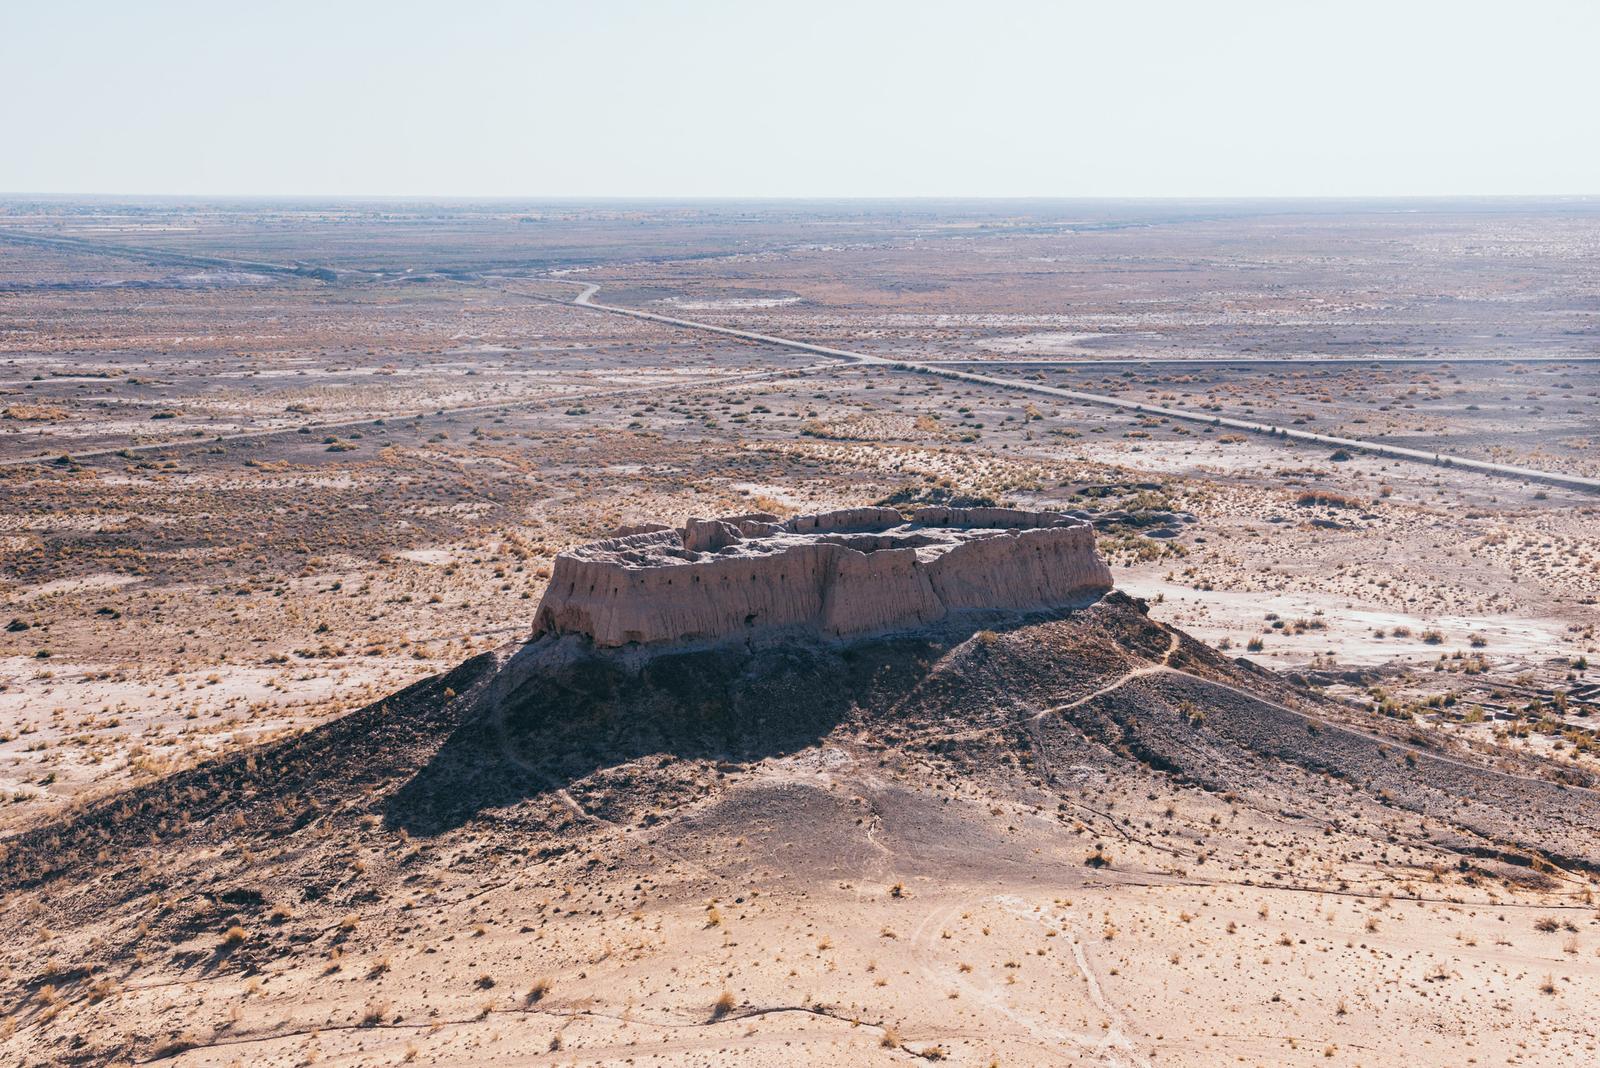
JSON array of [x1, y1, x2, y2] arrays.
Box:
[[0, 593, 1600, 1065]]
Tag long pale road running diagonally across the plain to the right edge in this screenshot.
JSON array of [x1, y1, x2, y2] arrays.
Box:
[[562, 280, 1600, 494]]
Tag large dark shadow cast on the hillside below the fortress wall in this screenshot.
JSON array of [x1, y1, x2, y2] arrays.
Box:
[[386, 620, 998, 836]]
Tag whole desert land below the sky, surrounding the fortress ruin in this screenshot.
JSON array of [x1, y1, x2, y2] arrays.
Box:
[[0, 198, 1600, 1068]]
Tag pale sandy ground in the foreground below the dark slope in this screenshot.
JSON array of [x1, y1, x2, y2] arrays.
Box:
[[12, 725, 1600, 1066]]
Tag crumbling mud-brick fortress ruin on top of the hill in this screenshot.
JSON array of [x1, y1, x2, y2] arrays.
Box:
[[534, 508, 1112, 648]]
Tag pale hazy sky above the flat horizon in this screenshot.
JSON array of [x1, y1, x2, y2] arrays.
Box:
[[0, 0, 1600, 197]]
